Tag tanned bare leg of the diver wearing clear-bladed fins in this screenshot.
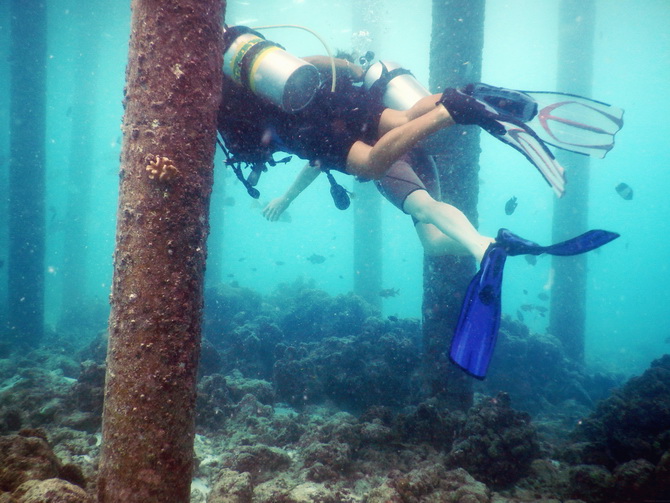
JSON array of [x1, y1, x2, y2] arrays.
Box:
[[347, 106, 454, 179]]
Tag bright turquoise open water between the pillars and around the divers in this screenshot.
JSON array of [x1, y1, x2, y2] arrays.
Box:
[[0, 0, 670, 373]]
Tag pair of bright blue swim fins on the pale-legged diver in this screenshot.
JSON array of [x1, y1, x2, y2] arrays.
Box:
[[449, 229, 619, 379]]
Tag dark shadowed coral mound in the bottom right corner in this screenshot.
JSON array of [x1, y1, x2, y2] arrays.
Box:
[[563, 355, 670, 501]]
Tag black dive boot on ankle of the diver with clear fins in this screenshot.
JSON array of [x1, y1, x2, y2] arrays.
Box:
[[437, 84, 505, 136]]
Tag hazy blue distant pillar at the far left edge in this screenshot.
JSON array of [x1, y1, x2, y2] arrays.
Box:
[[7, 0, 47, 348]]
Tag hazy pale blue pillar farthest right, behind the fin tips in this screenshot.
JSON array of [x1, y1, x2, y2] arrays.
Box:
[[549, 0, 596, 361]]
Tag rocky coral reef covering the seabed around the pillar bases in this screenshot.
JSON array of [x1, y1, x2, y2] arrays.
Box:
[[0, 282, 670, 503]]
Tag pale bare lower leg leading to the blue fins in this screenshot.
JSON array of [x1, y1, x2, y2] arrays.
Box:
[[403, 190, 494, 263]]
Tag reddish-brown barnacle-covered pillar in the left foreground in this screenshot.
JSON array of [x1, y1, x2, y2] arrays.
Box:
[[98, 0, 224, 503]]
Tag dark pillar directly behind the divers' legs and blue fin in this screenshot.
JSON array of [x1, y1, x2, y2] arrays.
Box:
[[423, 0, 485, 409]]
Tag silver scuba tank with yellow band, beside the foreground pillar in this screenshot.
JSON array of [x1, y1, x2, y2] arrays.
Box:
[[223, 26, 320, 112]]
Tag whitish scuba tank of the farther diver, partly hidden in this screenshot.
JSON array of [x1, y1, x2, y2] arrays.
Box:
[[364, 61, 430, 110]]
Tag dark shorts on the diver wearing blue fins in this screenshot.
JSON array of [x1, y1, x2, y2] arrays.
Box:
[[375, 148, 442, 216]]
